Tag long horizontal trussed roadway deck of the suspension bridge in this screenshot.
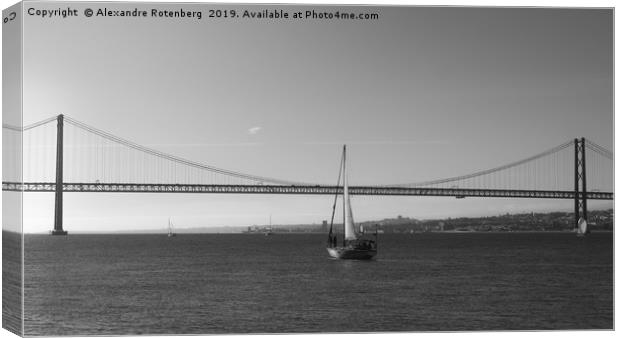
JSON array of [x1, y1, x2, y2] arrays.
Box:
[[2, 182, 614, 200]]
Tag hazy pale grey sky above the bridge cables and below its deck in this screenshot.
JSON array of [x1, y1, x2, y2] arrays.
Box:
[[13, 2, 613, 231]]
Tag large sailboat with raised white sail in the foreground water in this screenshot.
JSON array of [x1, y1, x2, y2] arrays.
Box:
[[327, 145, 377, 260]]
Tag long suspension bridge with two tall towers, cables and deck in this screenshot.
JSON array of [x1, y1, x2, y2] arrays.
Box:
[[2, 115, 614, 235]]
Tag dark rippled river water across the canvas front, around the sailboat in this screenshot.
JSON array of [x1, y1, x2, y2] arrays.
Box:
[[25, 233, 613, 335]]
